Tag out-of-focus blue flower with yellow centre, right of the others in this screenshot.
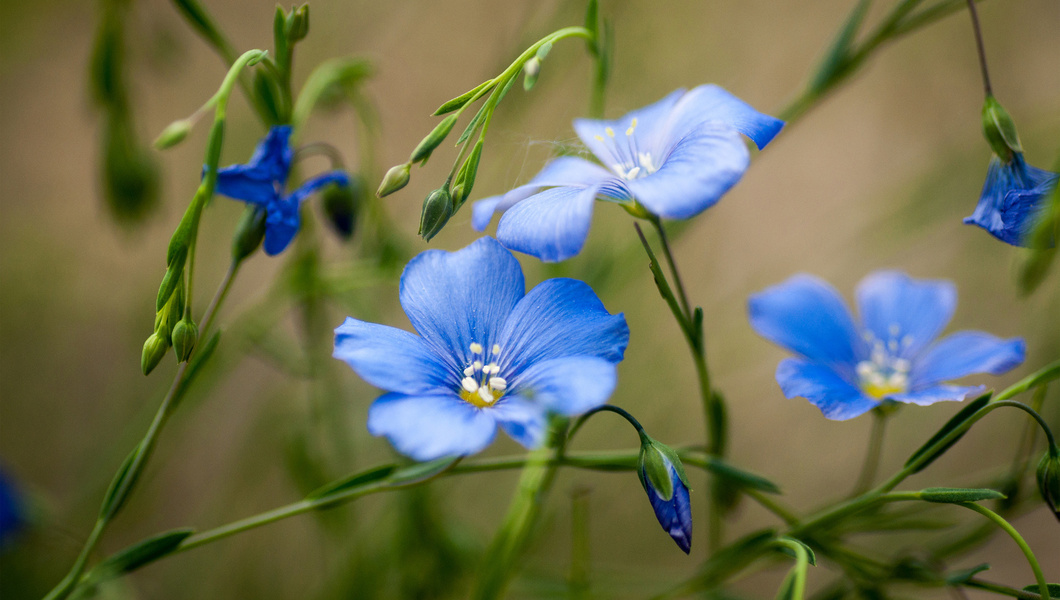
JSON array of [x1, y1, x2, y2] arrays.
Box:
[[747, 271, 1025, 420]]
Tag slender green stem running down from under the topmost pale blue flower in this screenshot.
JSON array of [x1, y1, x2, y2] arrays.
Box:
[[633, 222, 725, 551]]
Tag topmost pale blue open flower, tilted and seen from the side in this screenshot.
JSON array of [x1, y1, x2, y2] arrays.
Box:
[[472, 85, 783, 262]]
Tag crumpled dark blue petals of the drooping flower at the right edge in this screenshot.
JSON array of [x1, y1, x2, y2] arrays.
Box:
[[965, 153, 1060, 246]]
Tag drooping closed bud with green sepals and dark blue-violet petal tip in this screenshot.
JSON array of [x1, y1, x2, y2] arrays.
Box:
[[637, 435, 692, 554]]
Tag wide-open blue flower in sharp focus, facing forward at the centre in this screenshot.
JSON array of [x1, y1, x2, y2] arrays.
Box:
[[334, 237, 630, 460]]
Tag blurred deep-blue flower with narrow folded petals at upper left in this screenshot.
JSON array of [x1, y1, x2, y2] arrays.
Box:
[[216, 125, 350, 255]]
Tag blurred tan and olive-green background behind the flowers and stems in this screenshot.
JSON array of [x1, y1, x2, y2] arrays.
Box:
[[0, 0, 1060, 599]]
